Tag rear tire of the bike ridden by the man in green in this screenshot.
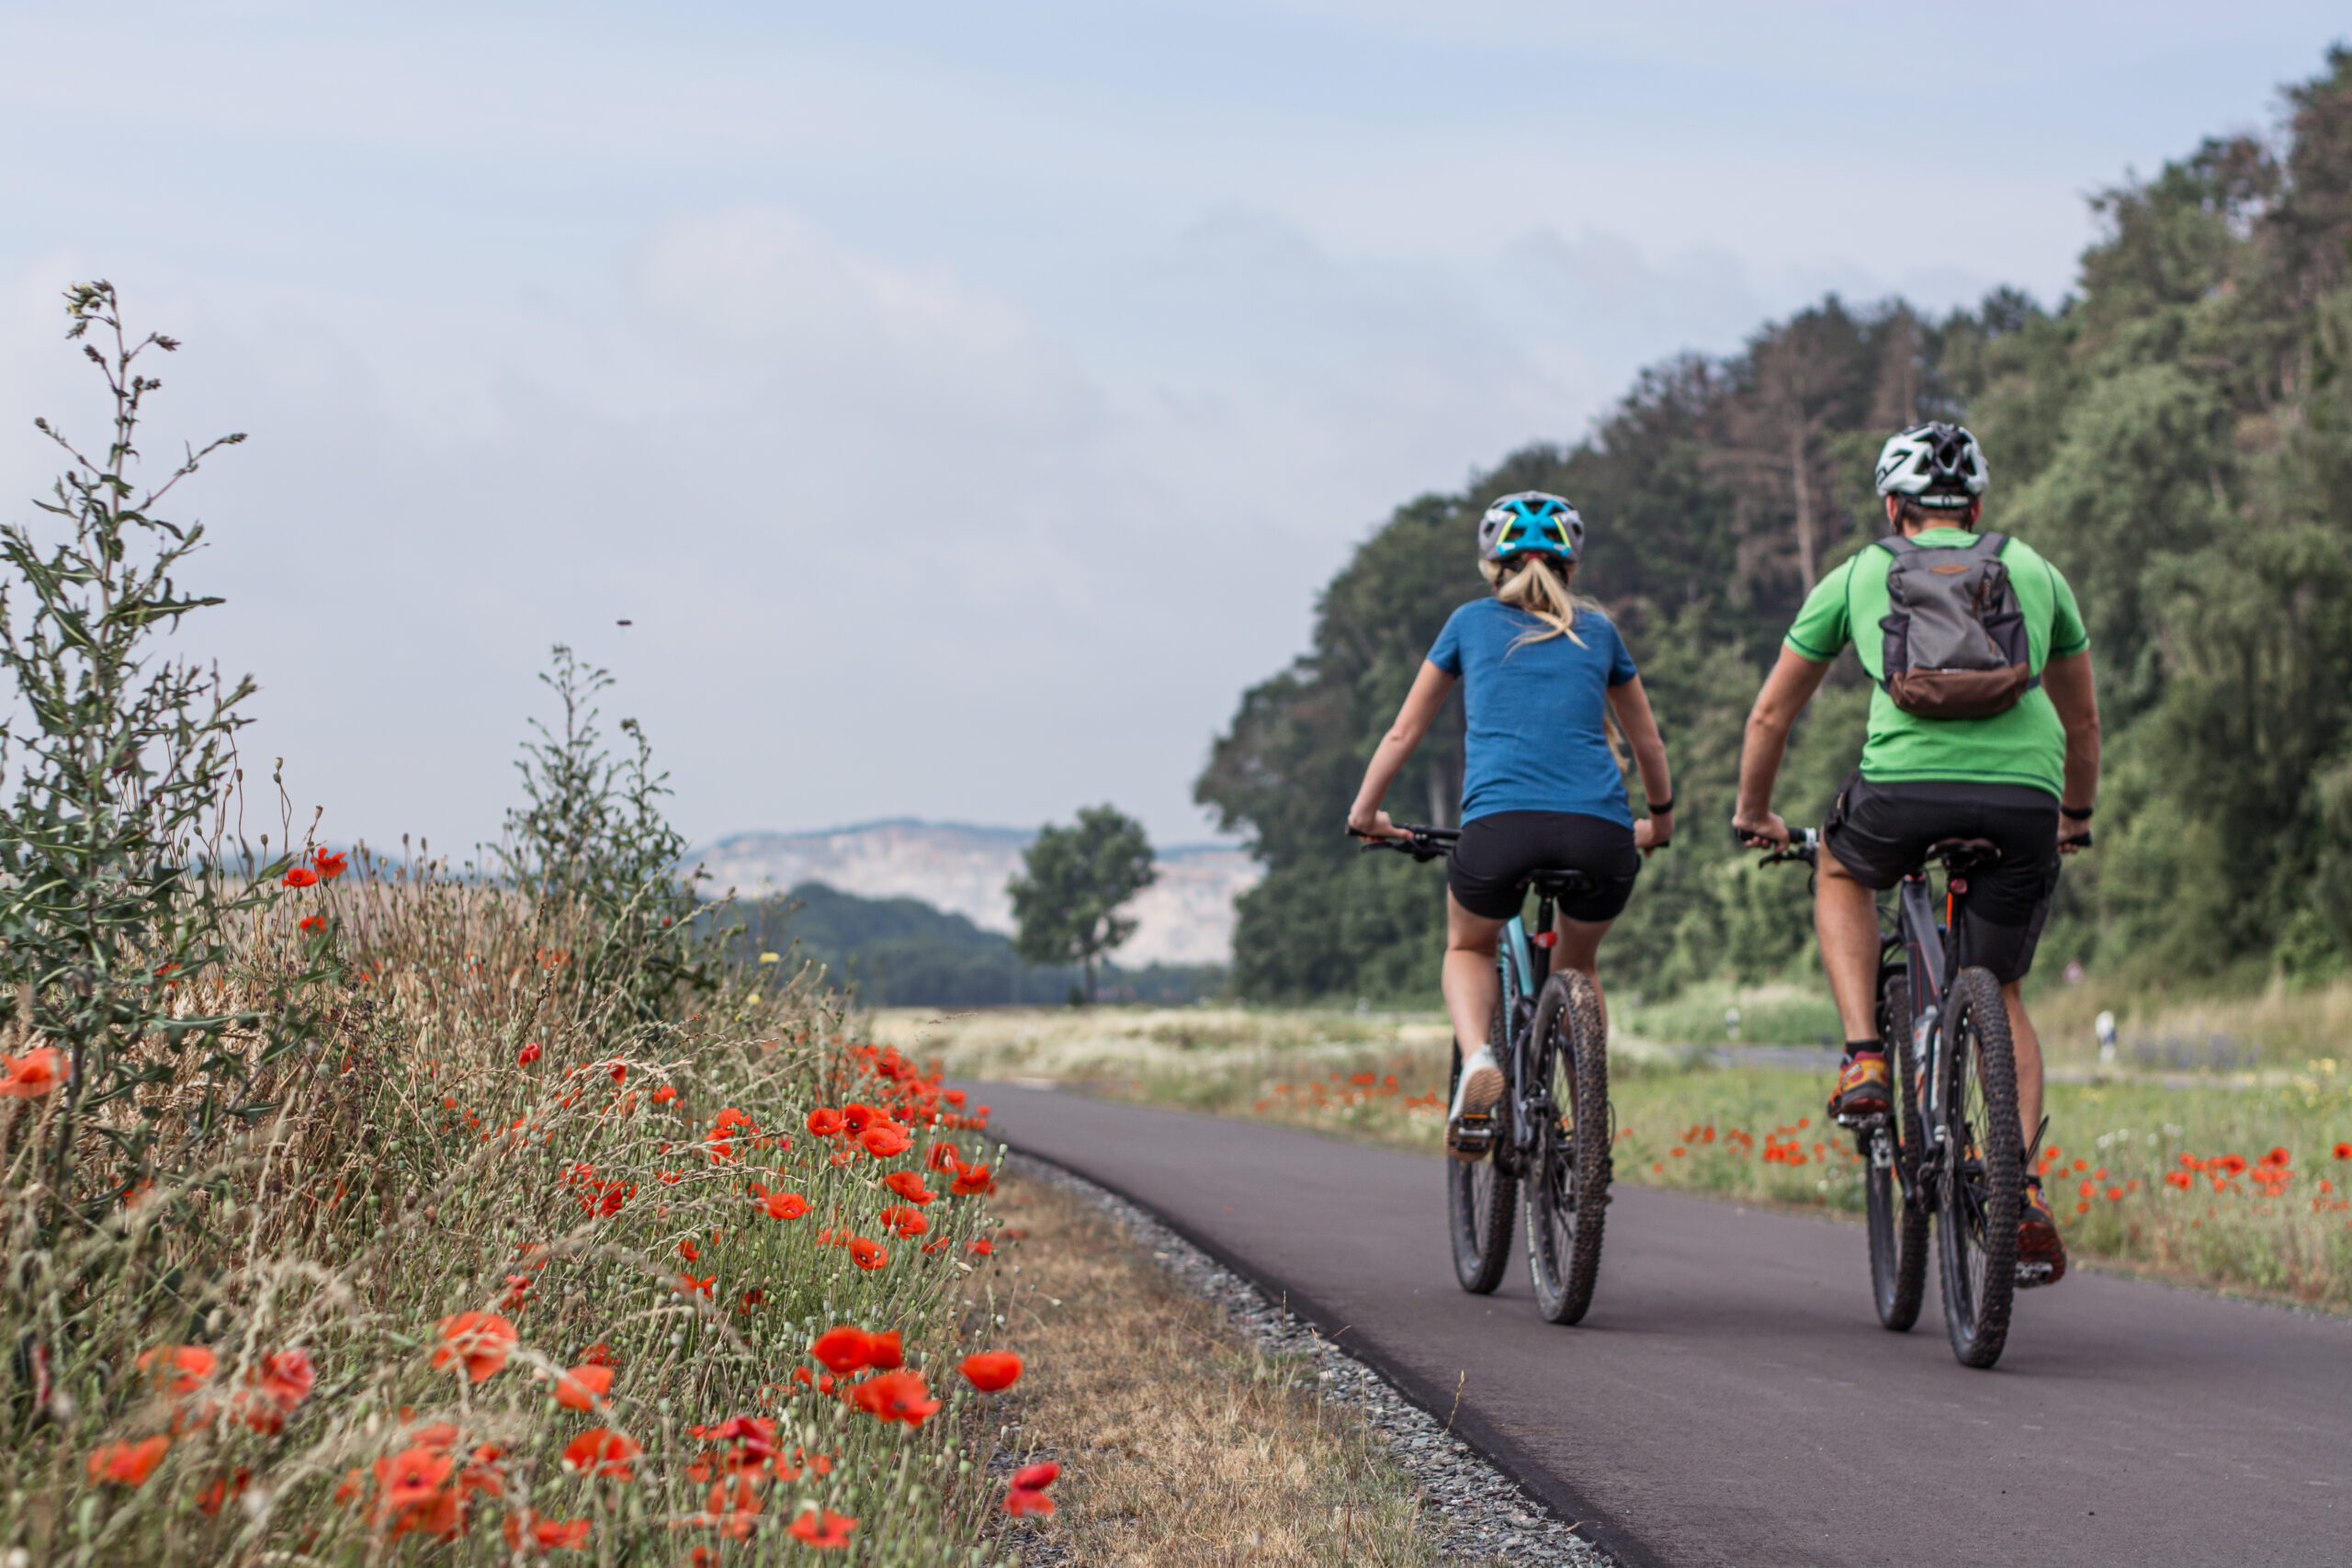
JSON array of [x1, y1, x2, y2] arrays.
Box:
[[1936, 968, 2025, 1368]]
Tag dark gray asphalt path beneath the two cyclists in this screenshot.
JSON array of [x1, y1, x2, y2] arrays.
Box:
[[967, 1084, 2352, 1568]]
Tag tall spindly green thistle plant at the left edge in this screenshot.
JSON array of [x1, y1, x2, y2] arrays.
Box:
[[0, 282, 324, 1201]]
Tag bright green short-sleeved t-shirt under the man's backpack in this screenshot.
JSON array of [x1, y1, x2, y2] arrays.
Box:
[[1788, 529, 2091, 795]]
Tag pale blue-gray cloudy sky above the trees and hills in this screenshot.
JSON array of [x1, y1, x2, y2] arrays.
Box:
[[0, 0, 2352, 860]]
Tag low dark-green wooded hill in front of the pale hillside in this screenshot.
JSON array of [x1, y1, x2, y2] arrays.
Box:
[[719, 882, 1226, 1006]]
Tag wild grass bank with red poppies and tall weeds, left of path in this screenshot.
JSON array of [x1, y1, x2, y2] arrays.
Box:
[[0, 285, 1056, 1563]]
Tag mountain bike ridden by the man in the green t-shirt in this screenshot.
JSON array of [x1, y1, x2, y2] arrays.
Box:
[[1769, 829, 2046, 1366]]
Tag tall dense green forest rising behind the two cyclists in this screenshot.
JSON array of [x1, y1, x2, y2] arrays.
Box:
[[1197, 47, 2352, 999]]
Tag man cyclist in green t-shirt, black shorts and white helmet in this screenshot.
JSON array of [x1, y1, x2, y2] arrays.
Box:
[[1731, 423, 2098, 1283]]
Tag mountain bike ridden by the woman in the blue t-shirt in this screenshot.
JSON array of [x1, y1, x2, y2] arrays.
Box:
[[1364, 828, 1616, 1324]]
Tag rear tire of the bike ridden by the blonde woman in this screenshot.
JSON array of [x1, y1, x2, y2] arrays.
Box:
[[1526, 968, 1613, 1324]]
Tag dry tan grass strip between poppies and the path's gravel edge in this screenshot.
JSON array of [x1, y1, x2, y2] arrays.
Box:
[[968, 1178, 1437, 1568]]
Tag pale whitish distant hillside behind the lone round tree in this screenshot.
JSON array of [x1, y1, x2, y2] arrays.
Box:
[[698, 818, 1261, 966]]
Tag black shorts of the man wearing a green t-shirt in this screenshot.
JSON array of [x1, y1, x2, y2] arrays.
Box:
[[1820, 773, 2058, 985]]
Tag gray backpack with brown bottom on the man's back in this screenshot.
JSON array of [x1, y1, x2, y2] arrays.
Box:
[[1879, 534, 2041, 719]]
